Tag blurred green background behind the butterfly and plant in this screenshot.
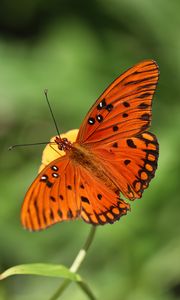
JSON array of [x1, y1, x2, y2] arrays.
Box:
[[0, 0, 180, 300]]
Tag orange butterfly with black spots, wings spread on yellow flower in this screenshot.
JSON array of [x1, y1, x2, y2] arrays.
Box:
[[21, 60, 159, 231]]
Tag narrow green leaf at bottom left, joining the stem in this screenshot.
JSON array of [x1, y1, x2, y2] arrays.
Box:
[[0, 263, 82, 282]]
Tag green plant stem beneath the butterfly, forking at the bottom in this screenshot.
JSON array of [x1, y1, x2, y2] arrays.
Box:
[[50, 225, 96, 300]]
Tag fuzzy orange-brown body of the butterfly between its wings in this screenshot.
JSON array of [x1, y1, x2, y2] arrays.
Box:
[[69, 143, 118, 193]]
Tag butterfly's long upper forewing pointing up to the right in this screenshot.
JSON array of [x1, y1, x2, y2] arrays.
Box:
[[77, 60, 159, 147]]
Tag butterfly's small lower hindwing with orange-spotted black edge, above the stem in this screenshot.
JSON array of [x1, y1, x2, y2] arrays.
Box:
[[77, 165, 130, 225]]
